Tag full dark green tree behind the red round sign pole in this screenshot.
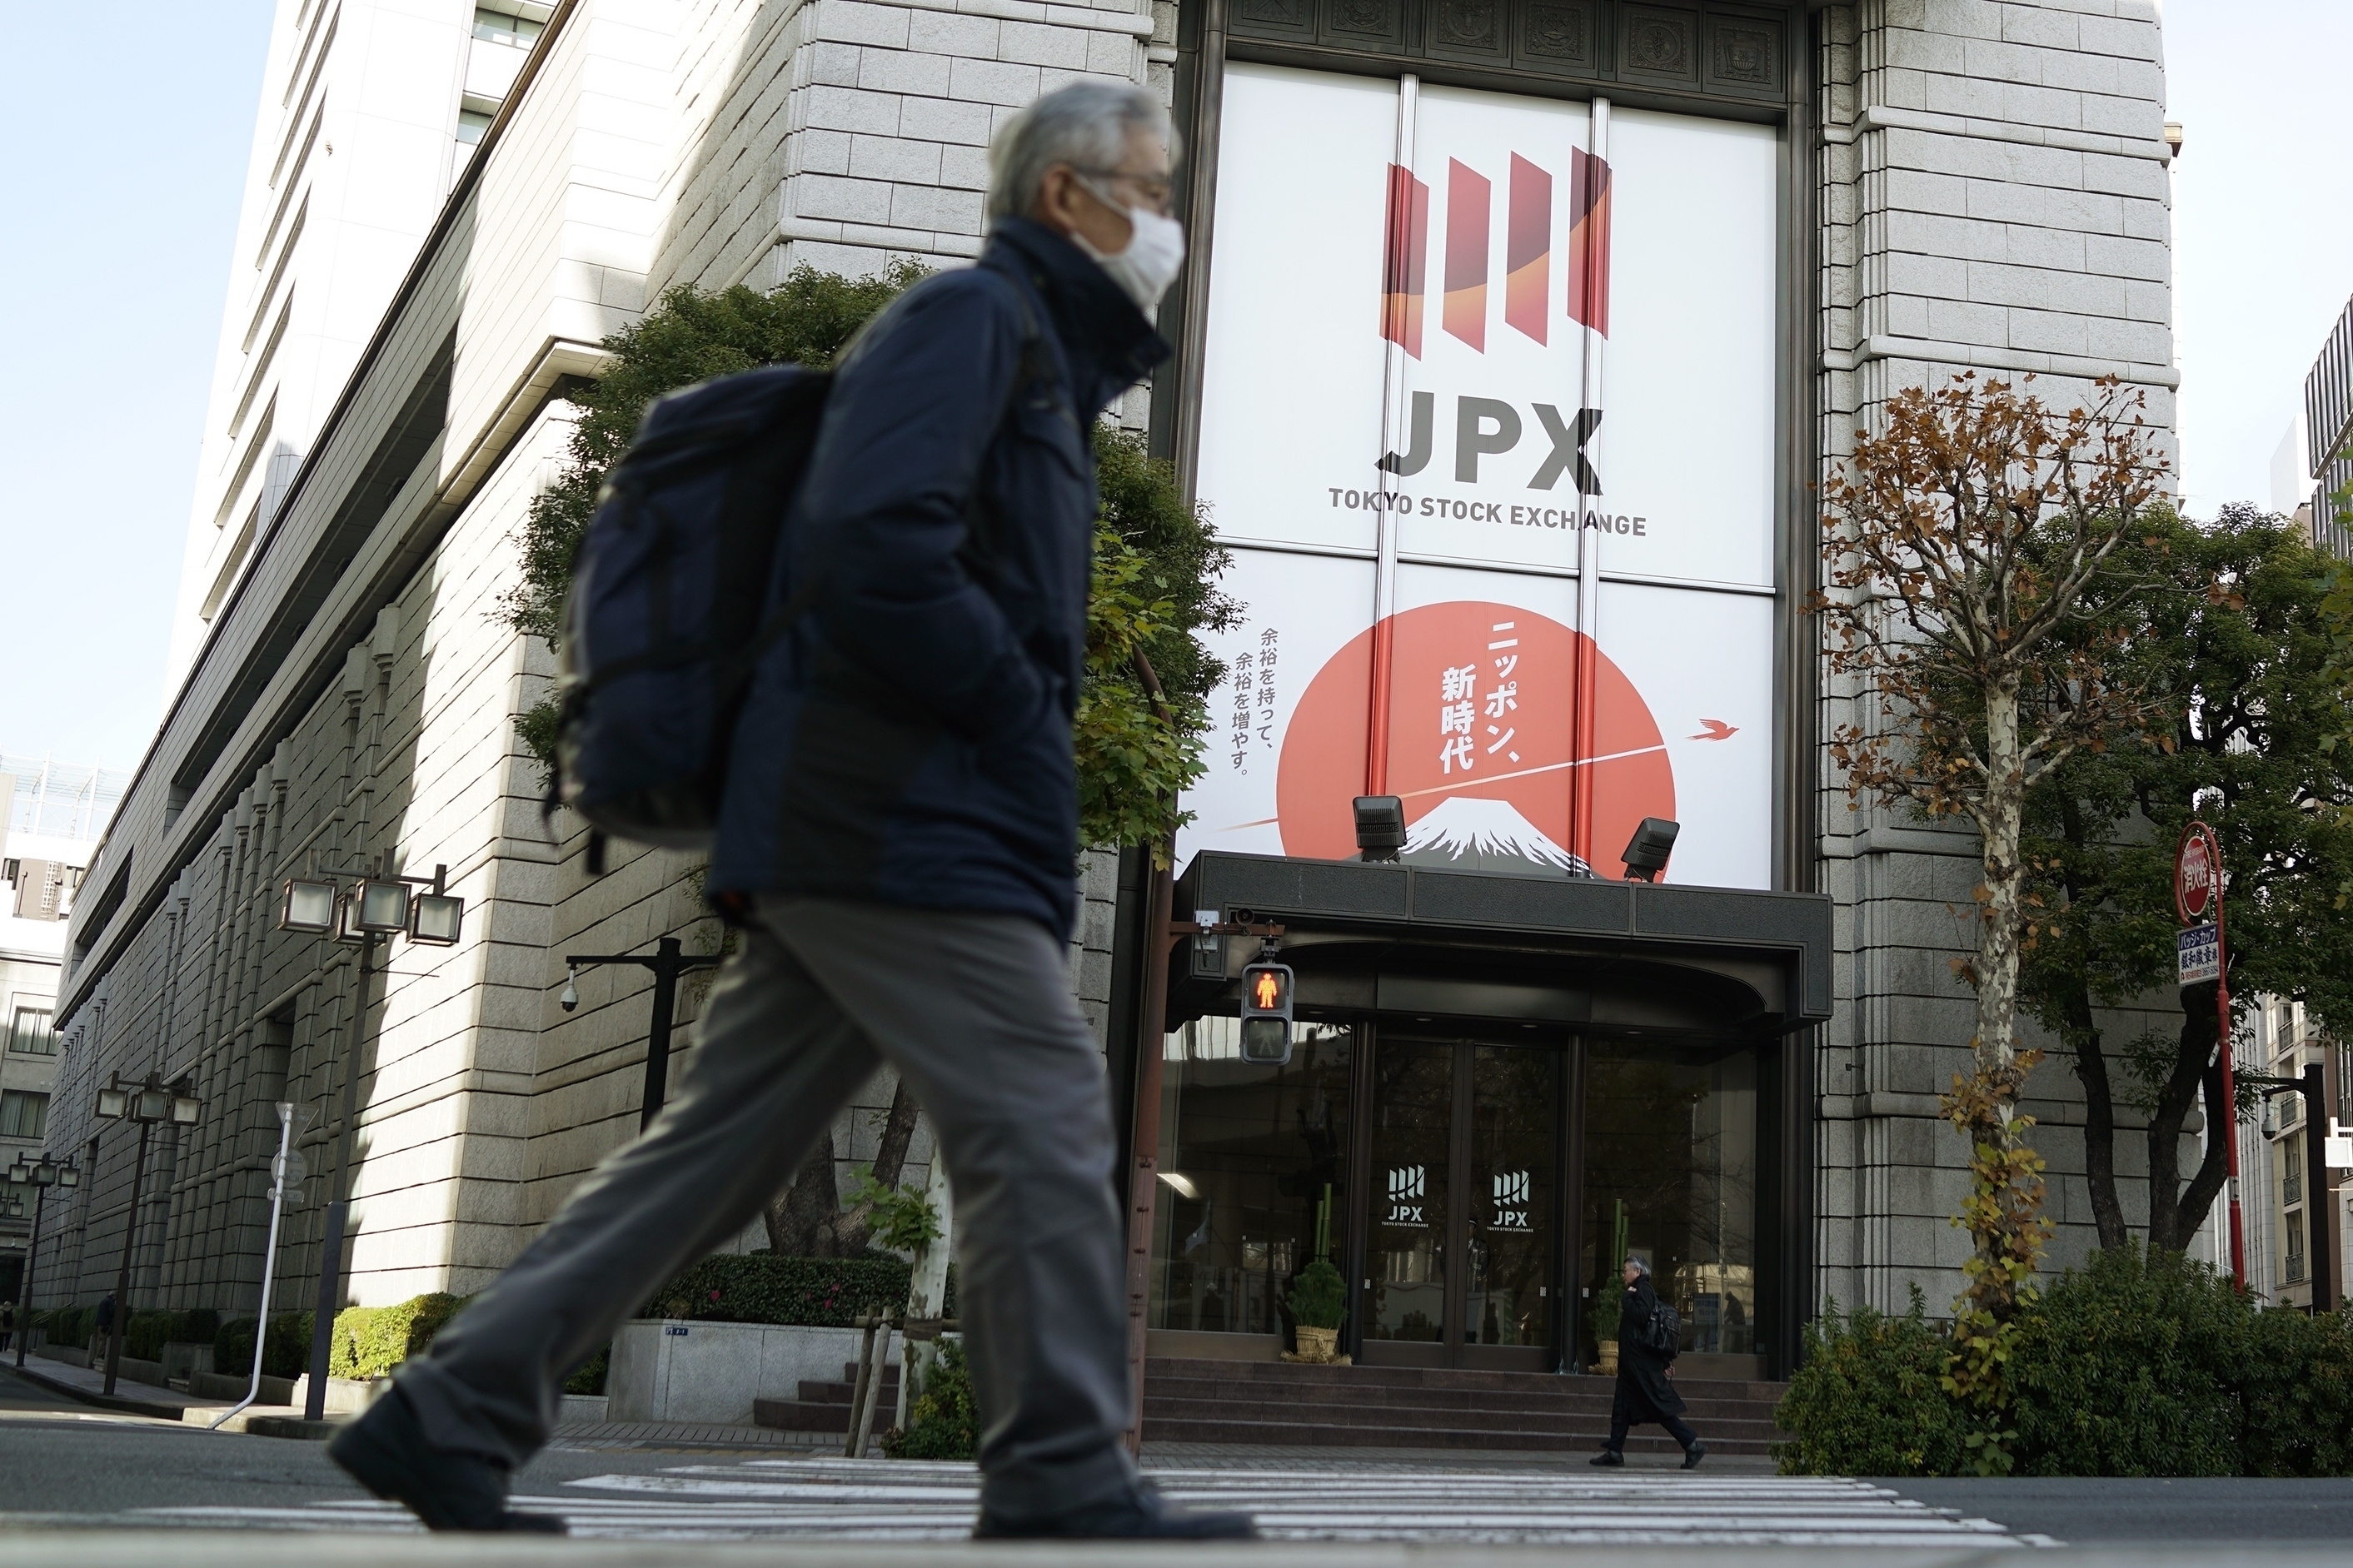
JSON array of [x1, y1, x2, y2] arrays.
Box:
[[2024, 505, 2353, 1251]]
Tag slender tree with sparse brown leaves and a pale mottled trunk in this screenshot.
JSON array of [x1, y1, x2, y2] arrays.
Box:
[[1814, 371, 2162, 1335]]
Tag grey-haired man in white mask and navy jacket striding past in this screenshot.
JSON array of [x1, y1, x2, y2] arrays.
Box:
[[330, 82, 1252, 1537]]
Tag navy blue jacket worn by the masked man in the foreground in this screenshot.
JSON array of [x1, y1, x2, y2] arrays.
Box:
[[710, 219, 1169, 940]]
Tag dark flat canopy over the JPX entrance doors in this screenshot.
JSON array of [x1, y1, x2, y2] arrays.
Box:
[[1167, 851, 1831, 1042]]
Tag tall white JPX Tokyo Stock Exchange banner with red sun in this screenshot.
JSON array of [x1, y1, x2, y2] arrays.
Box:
[[1179, 63, 1779, 886]]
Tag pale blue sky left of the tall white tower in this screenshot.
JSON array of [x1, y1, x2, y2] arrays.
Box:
[[0, 0, 273, 769]]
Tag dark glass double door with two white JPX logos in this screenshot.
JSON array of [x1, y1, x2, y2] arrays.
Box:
[[1363, 1037, 1560, 1371]]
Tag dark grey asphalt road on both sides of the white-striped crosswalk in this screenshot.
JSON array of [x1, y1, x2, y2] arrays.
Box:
[[13, 1376, 2353, 1554]]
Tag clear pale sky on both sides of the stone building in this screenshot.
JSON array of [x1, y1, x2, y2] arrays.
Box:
[[0, 0, 2353, 766]]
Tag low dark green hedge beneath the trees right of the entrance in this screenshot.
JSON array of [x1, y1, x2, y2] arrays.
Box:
[[1774, 1246, 2353, 1476]]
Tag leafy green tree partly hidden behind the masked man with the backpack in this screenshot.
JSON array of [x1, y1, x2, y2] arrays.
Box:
[[501, 263, 1240, 854]]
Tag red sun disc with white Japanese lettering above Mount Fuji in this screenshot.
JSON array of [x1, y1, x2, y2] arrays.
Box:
[[1275, 600, 1675, 877]]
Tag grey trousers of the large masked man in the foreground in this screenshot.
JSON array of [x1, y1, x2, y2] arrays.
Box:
[[397, 898, 1134, 1521]]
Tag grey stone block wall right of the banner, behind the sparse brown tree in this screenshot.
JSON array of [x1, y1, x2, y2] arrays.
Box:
[[1814, 0, 2196, 1312]]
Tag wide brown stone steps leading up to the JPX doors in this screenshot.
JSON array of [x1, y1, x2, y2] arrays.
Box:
[[1144, 1356, 1788, 1455]]
